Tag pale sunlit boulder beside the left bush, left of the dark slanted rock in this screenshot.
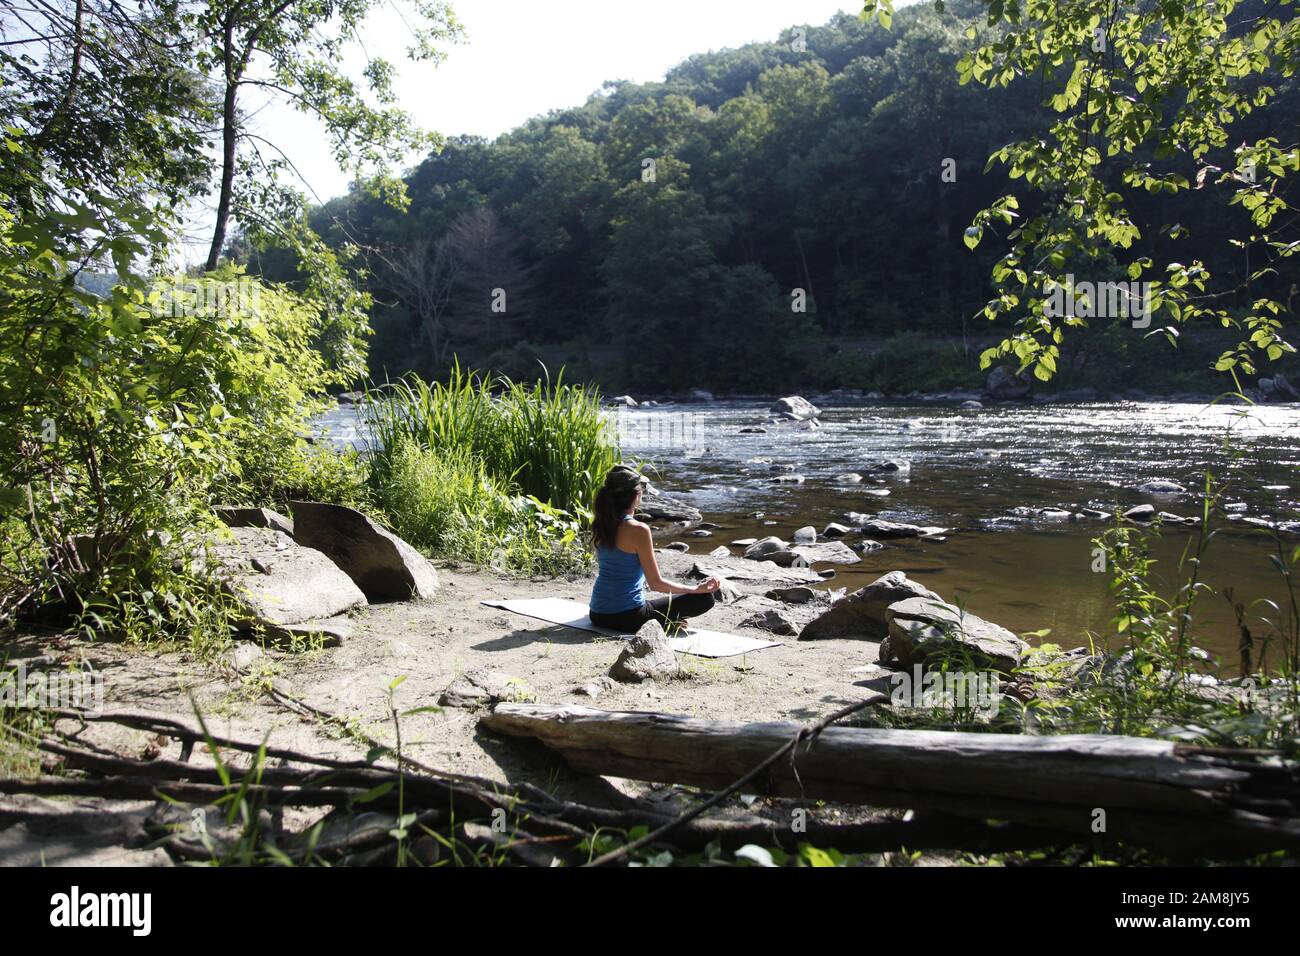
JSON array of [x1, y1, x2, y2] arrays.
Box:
[[209, 528, 365, 631]]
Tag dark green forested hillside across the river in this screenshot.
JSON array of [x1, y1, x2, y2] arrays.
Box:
[[242, 0, 1300, 393]]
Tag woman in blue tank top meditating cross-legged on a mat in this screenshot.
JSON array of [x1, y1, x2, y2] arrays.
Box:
[[592, 464, 722, 633]]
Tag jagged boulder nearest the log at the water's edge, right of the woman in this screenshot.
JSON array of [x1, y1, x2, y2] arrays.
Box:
[[880, 597, 1030, 674]]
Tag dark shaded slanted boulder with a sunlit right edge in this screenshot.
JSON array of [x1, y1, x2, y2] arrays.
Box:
[[290, 501, 438, 601]]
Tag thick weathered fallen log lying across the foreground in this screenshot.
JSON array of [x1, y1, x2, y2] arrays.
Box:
[[480, 704, 1300, 858]]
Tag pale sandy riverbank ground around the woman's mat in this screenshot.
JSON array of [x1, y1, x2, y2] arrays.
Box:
[[0, 551, 925, 863]]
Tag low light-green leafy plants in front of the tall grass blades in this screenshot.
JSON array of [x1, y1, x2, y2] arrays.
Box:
[[377, 440, 590, 574]]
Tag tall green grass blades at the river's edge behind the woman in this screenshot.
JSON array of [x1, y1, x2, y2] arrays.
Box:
[[363, 364, 619, 520]]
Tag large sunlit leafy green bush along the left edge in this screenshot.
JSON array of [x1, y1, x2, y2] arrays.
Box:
[[0, 127, 356, 636]]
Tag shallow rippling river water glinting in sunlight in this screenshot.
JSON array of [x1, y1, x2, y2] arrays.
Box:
[[321, 402, 1300, 669]]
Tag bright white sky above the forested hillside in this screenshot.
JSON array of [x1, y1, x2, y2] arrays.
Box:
[[246, 0, 862, 200]]
